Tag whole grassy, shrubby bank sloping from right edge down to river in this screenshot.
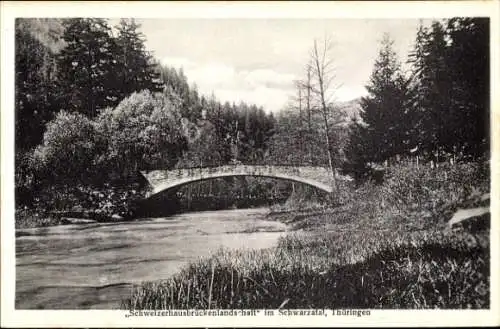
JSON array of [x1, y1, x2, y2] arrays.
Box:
[[122, 163, 490, 309]]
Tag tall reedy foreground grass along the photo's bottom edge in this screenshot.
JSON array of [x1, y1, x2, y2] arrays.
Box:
[[122, 228, 489, 309]]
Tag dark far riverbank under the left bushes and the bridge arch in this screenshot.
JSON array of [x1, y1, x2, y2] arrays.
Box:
[[15, 186, 284, 229]]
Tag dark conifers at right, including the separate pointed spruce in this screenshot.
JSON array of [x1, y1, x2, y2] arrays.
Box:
[[343, 18, 490, 178]]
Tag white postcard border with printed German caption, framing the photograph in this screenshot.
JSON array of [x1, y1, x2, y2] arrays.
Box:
[[0, 0, 500, 327]]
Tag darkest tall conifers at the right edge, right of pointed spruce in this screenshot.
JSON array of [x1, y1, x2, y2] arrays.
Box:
[[410, 18, 489, 162]]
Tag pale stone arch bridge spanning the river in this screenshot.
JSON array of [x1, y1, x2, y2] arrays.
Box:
[[141, 165, 342, 197]]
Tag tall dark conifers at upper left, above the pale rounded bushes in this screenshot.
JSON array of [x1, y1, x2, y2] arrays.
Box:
[[15, 18, 162, 149]]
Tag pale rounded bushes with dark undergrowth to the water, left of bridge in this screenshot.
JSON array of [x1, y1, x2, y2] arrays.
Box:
[[16, 91, 191, 223]]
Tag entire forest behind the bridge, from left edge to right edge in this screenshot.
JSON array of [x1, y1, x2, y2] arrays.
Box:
[[15, 18, 490, 223]]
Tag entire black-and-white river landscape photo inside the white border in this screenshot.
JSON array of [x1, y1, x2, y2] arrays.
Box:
[[2, 4, 498, 323]]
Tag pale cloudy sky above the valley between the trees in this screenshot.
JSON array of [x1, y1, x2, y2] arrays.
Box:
[[136, 18, 419, 112]]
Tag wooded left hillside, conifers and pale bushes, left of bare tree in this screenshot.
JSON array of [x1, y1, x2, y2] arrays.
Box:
[[16, 18, 275, 206]]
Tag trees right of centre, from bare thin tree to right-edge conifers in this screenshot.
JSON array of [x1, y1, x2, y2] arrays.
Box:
[[270, 18, 490, 181]]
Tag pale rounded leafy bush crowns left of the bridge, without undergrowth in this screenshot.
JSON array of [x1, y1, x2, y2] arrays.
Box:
[[26, 91, 185, 184]]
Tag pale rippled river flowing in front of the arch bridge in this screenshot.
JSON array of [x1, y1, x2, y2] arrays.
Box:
[[16, 208, 286, 309]]
